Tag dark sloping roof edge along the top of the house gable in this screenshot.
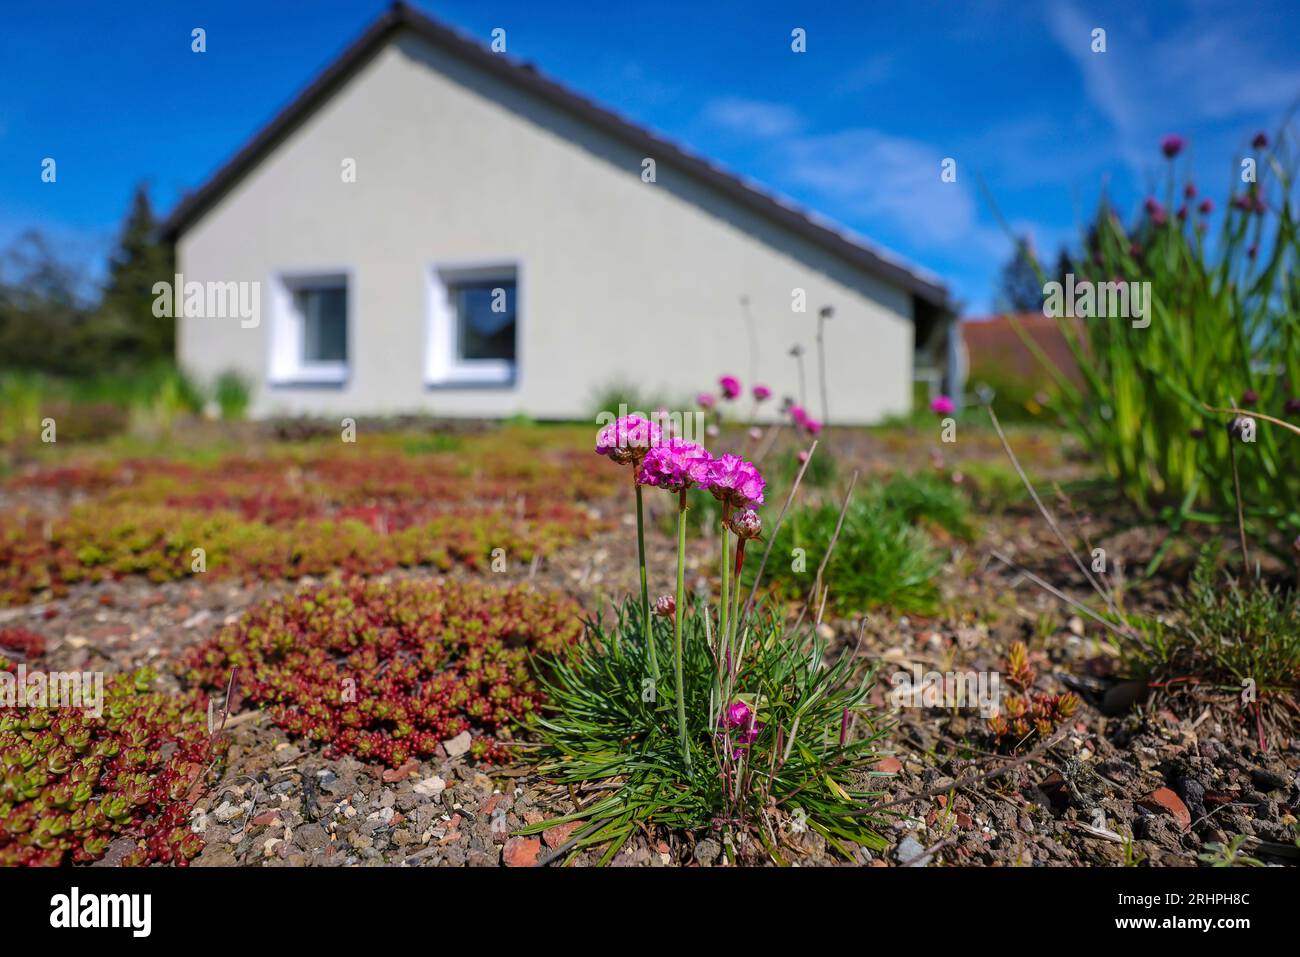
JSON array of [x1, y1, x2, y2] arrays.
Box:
[[160, 3, 949, 308]]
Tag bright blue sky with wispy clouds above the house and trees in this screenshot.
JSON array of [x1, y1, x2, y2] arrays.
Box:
[[0, 0, 1300, 312]]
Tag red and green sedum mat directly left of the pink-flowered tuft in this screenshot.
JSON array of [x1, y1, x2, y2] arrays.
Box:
[[182, 579, 581, 767]]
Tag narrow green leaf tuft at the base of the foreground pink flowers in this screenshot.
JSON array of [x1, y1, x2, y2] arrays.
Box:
[[524, 602, 884, 863]]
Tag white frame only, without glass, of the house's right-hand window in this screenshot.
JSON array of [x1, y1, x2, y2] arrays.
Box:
[[424, 257, 525, 389]]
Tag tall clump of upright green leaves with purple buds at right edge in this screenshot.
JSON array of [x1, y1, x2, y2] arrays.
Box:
[[1024, 130, 1300, 538]]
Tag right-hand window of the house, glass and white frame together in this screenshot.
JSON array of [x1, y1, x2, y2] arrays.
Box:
[[426, 265, 519, 386]]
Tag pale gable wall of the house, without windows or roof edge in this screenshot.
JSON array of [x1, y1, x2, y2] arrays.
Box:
[[178, 36, 913, 423]]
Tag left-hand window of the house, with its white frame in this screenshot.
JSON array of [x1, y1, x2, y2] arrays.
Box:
[[270, 274, 348, 385]]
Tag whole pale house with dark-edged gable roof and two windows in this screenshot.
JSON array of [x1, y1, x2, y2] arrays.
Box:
[[164, 4, 957, 423]]
